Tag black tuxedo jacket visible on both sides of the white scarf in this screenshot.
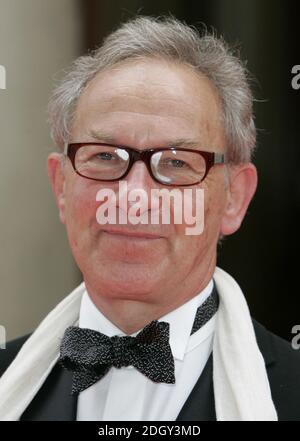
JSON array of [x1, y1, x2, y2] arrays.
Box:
[[0, 320, 300, 421]]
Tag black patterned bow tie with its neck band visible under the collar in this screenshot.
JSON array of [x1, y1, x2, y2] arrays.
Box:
[[59, 280, 219, 394]]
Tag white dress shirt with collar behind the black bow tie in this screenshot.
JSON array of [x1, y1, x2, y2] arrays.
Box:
[[76, 279, 216, 421]]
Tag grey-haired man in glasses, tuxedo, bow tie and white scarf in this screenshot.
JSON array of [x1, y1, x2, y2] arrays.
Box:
[[0, 13, 300, 421]]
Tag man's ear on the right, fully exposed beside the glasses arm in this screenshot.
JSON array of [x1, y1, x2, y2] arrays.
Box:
[[220, 163, 257, 235]]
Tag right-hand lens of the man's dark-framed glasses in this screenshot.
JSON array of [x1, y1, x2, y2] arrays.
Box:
[[151, 150, 206, 185]]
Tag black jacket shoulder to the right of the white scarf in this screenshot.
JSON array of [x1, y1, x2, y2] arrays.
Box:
[[253, 320, 300, 421]]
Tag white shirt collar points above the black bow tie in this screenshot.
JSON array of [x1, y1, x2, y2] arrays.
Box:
[[79, 279, 213, 360]]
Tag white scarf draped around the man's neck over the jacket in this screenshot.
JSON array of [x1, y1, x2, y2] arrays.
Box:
[[0, 267, 277, 421]]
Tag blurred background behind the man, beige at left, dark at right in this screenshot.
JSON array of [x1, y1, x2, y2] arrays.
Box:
[[0, 0, 300, 340]]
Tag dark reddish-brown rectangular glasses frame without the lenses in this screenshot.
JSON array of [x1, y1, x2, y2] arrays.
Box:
[[63, 142, 225, 187]]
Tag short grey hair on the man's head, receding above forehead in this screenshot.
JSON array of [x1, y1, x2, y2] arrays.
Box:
[[48, 16, 256, 164]]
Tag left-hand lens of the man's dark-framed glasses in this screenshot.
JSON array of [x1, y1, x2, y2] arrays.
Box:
[[75, 145, 129, 181]]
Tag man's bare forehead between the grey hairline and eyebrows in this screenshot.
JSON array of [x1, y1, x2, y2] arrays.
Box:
[[74, 62, 222, 141]]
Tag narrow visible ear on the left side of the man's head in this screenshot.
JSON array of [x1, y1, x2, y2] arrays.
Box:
[[47, 153, 65, 224]]
